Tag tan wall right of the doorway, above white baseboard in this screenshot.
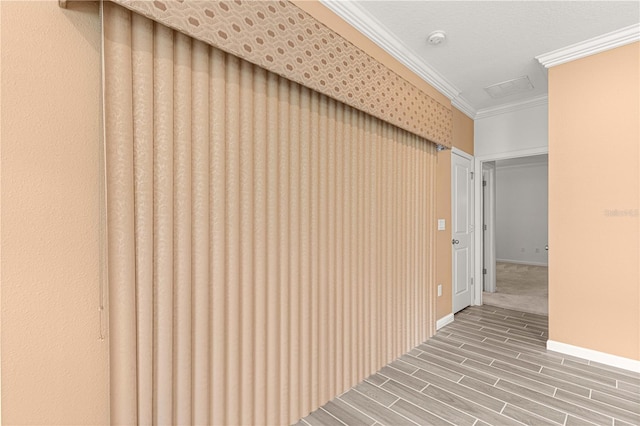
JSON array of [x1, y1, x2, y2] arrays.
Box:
[[549, 43, 640, 360]]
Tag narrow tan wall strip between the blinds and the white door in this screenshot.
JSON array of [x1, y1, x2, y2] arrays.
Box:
[[436, 108, 473, 319]]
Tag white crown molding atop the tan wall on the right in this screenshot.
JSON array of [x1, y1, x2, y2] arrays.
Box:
[[536, 24, 640, 68]]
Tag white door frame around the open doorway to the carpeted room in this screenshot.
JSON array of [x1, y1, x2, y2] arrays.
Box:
[[473, 146, 549, 305]]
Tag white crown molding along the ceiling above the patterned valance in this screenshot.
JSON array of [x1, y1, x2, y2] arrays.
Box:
[[320, 0, 462, 104]]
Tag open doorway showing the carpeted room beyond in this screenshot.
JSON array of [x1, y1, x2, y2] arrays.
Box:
[[477, 153, 548, 315]]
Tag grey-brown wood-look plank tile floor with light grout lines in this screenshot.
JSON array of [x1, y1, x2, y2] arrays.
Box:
[[298, 305, 640, 426]]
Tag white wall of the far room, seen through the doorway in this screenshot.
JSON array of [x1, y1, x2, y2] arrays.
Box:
[[496, 162, 549, 265]]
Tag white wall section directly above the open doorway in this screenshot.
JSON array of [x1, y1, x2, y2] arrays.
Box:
[[474, 104, 549, 159]]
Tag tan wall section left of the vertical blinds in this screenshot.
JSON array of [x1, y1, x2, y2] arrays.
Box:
[[0, 1, 109, 425]]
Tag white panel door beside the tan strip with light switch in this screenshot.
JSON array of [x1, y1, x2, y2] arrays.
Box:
[[451, 151, 473, 313]]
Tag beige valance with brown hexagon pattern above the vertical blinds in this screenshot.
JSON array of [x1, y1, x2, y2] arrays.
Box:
[[107, 0, 452, 147]]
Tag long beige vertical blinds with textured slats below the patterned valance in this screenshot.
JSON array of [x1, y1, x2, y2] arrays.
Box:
[[104, 3, 435, 425]]
